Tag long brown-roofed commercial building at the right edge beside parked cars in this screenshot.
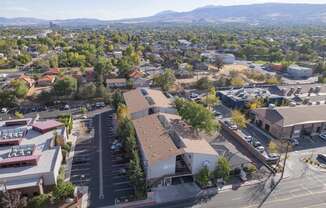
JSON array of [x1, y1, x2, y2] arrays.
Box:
[[254, 105, 326, 139]]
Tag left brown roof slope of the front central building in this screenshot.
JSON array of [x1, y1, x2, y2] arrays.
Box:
[[133, 114, 183, 165]]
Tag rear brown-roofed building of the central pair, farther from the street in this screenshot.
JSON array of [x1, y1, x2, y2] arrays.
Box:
[[123, 88, 177, 119]]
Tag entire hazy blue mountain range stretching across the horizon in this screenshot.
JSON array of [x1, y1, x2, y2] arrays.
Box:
[[0, 3, 326, 26]]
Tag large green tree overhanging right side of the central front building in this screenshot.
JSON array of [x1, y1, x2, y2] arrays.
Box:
[[175, 99, 219, 134]]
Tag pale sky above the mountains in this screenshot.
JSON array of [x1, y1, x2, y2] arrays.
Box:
[[0, 0, 326, 20]]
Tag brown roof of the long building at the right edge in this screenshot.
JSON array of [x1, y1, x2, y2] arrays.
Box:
[[255, 105, 326, 127]]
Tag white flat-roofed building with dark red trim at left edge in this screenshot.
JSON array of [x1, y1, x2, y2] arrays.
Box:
[[0, 119, 66, 195]]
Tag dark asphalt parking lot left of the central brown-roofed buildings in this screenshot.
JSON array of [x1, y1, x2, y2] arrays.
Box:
[[81, 111, 134, 207]]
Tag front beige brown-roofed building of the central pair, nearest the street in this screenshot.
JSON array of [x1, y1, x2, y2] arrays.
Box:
[[133, 113, 218, 185]]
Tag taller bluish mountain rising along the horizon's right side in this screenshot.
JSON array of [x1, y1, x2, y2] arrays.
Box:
[[124, 3, 326, 24]]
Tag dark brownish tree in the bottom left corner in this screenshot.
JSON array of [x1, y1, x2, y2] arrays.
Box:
[[0, 191, 27, 208]]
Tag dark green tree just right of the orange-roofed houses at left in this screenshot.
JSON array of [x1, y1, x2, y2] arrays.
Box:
[[53, 76, 77, 96]]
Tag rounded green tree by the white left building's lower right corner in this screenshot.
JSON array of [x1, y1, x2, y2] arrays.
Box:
[[53, 181, 75, 202]]
